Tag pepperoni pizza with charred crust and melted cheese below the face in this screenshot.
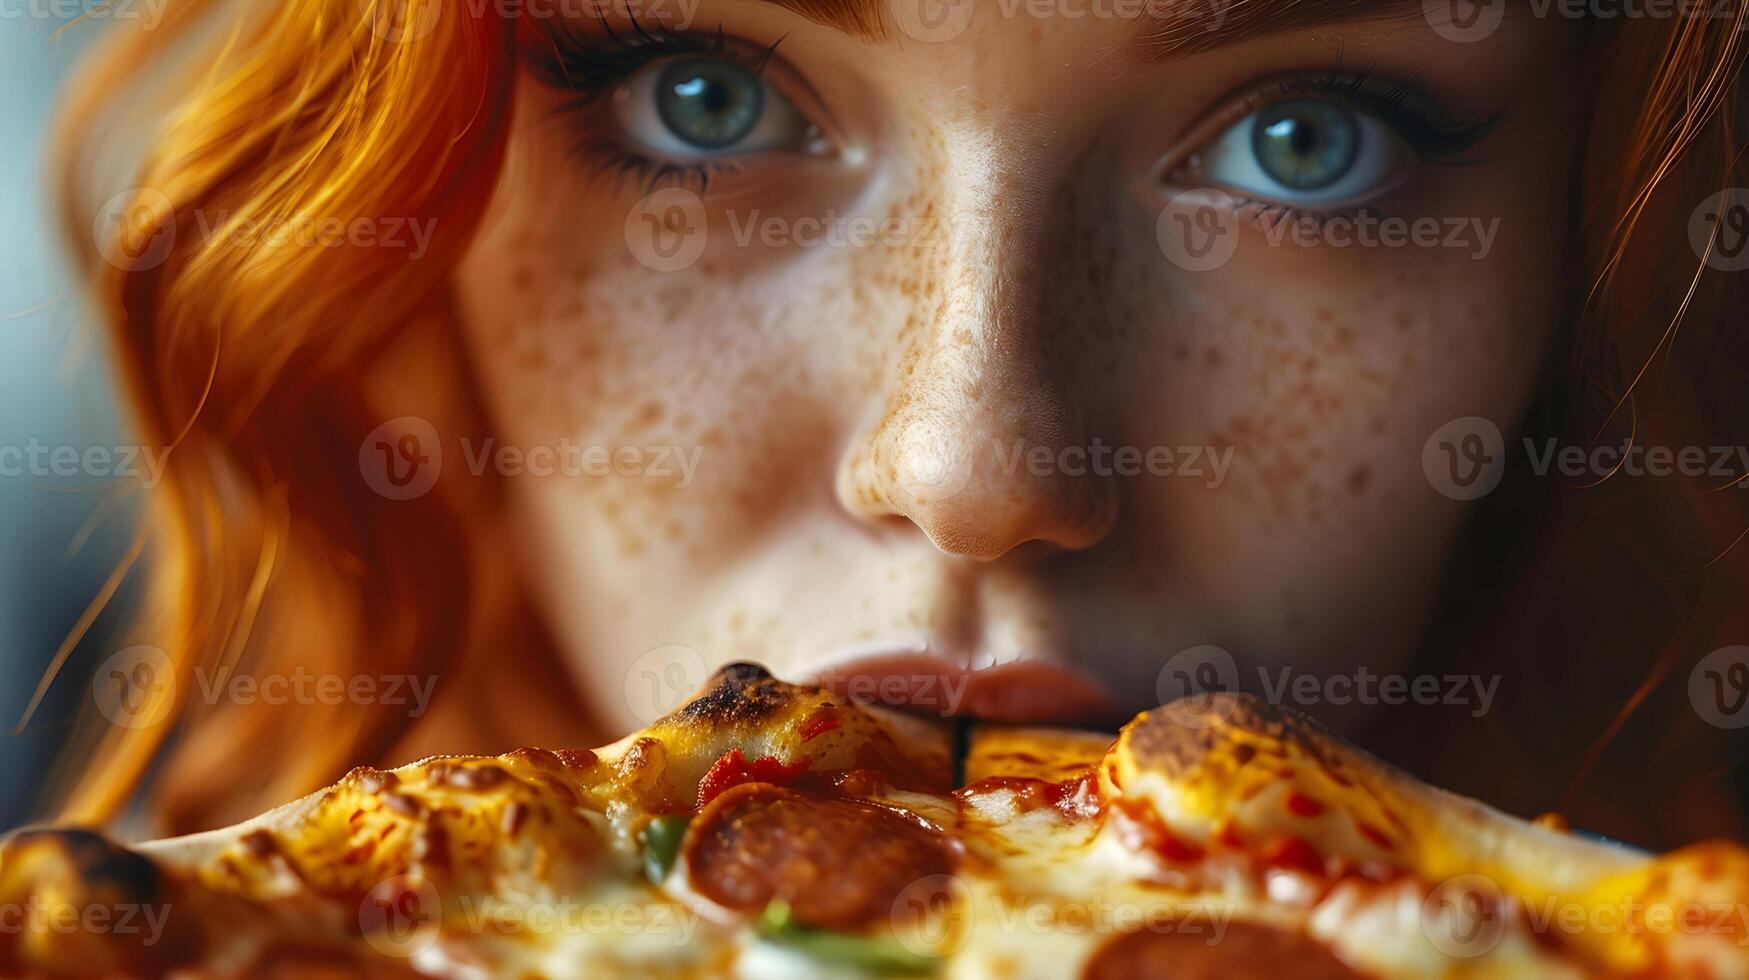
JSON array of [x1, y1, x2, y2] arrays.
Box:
[[0, 665, 1749, 980]]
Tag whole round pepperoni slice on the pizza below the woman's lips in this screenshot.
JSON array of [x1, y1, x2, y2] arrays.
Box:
[[680, 782, 958, 929]]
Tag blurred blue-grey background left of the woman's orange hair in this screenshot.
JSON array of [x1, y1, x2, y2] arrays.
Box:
[[0, 13, 135, 831]]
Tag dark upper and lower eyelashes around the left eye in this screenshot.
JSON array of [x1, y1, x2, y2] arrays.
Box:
[[523, 18, 784, 194]]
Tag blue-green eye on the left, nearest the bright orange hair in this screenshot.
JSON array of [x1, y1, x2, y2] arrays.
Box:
[[614, 56, 813, 161]]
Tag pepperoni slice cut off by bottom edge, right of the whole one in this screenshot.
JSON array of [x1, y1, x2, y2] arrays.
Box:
[[1083, 921, 1364, 980]]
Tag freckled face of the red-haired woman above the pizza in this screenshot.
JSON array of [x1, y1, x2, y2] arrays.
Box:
[[458, 0, 1581, 730]]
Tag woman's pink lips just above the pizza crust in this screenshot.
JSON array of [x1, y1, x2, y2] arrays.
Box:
[[810, 653, 1125, 728]]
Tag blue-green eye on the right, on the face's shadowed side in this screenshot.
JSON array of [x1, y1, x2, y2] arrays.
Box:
[[1200, 98, 1413, 205]]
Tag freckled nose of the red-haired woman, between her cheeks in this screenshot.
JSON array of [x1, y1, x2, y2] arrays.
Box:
[[836, 157, 1116, 560]]
